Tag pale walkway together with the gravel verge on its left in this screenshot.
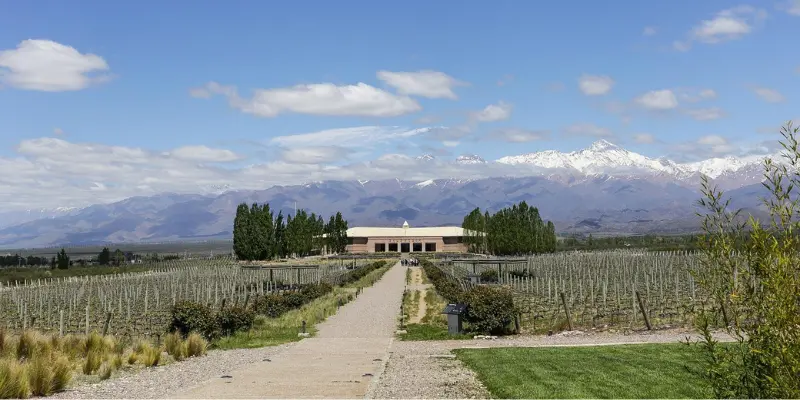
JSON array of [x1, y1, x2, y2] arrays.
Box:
[[52, 263, 405, 399]]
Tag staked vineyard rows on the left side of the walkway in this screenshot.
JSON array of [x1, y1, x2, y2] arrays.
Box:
[[0, 258, 368, 337]]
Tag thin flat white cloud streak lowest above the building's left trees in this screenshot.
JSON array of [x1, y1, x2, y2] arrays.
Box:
[[269, 126, 435, 148]]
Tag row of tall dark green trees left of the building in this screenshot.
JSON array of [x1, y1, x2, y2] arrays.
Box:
[[228, 203, 347, 261]]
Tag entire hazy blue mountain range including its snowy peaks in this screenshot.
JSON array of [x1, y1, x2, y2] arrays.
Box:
[[0, 140, 775, 248]]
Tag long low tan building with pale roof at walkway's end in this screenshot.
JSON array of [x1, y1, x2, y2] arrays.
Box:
[[347, 221, 467, 253]]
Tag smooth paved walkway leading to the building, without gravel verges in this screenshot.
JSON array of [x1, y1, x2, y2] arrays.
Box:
[[174, 263, 406, 399]]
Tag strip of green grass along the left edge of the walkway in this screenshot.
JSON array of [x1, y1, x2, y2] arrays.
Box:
[[213, 264, 394, 350]]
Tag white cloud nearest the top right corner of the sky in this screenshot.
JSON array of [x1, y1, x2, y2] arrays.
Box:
[[673, 6, 767, 51]]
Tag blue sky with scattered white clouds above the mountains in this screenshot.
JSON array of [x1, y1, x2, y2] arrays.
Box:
[[0, 0, 800, 209]]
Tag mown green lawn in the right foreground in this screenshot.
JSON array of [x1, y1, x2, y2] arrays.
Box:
[[454, 343, 713, 399]]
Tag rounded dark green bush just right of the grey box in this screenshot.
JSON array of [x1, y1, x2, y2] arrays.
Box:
[[465, 286, 516, 334]]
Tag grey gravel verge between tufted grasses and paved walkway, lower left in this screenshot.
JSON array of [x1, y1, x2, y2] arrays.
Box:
[[51, 343, 295, 399]]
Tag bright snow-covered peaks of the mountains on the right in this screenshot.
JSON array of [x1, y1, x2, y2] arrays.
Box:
[[496, 140, 776, 187]]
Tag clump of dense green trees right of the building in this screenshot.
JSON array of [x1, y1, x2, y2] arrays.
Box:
[[461, 201, 556, 256]]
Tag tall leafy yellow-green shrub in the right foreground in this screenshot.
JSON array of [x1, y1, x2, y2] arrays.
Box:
[[693, 122, 800, 398]]
